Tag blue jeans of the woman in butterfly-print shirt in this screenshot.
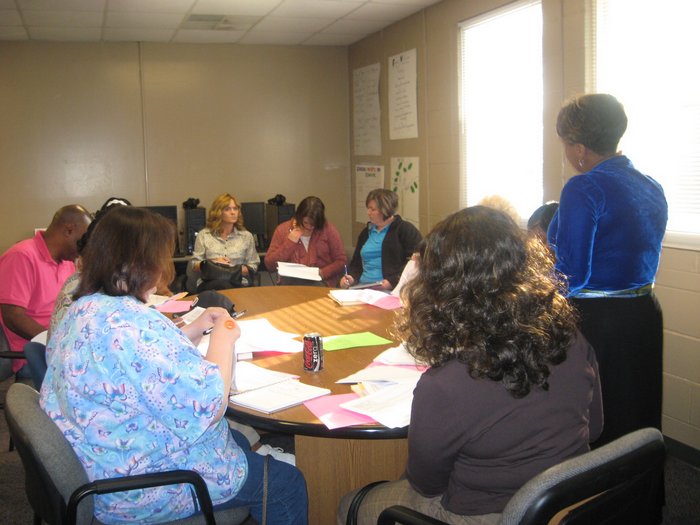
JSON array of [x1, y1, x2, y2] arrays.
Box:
[[214, 429, 309, 525]]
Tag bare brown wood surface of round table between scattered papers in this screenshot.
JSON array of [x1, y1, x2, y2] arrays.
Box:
[[220, 286, 408, 439]]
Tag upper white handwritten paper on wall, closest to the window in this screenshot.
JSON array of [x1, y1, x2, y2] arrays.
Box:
[[389, 49, 418, 140]]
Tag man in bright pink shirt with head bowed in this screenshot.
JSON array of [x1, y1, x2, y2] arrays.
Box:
[[0, 204, 91, 377]]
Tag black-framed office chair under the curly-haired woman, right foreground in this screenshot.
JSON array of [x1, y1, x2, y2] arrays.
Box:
[[377, 428, 666, 525]]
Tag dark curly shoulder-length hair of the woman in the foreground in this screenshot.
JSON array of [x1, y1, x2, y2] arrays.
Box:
[[395, 206, 576, 398]]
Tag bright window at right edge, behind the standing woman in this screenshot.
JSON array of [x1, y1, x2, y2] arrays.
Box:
[[588, 0, 700, 249]]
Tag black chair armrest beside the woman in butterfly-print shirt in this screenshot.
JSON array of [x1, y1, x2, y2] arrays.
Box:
[[66, 470, 216, 525]]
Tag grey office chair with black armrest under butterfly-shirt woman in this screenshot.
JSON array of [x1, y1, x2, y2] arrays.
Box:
[[5, 383, 249, 525]]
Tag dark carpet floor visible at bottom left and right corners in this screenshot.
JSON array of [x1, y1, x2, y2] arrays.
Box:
[[0, 374, 700, 525]]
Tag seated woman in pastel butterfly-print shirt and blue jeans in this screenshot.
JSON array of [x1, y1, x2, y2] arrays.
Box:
[[41, 206, 307, 525]]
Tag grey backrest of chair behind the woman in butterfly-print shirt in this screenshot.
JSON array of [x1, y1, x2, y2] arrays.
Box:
[[5, 383, 94, 524]]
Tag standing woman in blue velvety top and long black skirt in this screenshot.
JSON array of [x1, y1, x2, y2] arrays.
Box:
[[548, 94, 668, 446]]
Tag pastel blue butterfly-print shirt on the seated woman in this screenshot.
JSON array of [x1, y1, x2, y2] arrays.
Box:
[[41, 293, 248, 524]]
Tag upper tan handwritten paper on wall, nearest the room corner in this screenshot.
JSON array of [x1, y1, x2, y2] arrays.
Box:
[[352, 64, 382, 155]]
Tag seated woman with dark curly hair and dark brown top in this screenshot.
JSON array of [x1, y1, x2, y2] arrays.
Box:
[[338, 206, 603, 524]]
